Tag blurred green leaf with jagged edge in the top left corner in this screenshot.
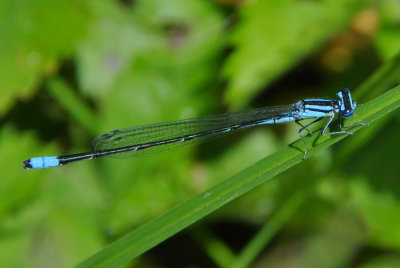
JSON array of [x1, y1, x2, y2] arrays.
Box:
[[0, 0, 90, 113]]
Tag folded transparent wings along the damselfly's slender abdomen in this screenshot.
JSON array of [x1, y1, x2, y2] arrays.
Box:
[[93, 105, 293, 158]]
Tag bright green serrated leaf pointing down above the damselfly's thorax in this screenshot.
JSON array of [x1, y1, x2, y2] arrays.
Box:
[[224, 0, 371, 107]]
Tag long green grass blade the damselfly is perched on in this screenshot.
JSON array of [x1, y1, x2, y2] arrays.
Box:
[[77, 86, 400, 268]]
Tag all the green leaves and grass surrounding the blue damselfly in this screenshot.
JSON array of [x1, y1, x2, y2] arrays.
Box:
[[0, 0, 400, 267]]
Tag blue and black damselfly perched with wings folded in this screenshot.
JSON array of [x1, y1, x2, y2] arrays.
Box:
[[23, 88, 365, 169]]
